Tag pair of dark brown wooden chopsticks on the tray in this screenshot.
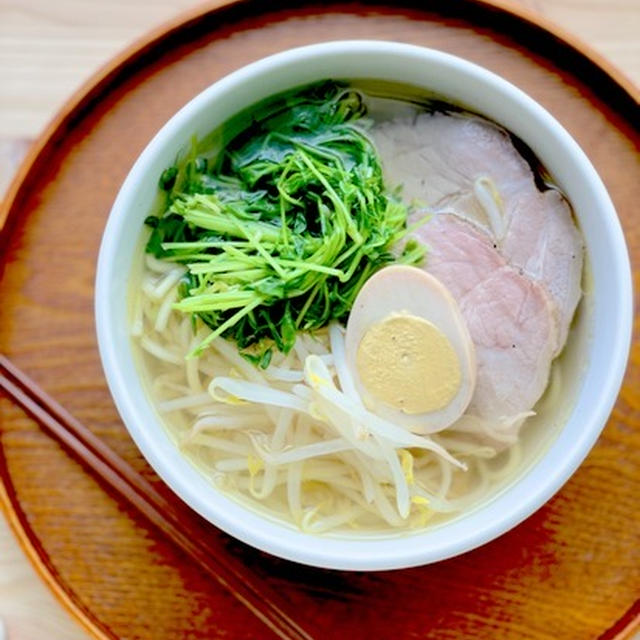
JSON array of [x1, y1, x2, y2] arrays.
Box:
[[0, 354, 313, 640]]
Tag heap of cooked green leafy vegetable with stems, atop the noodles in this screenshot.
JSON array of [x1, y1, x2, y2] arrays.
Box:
[[146, 83, 424, 358]]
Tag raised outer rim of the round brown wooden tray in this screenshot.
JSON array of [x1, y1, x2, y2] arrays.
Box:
[[0, 0, 640, 640]]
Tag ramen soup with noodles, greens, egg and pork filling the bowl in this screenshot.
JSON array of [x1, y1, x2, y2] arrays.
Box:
[[132, 82, 584, 535]]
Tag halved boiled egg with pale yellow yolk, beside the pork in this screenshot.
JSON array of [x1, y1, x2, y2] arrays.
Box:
[[345, 265, 476, 433]]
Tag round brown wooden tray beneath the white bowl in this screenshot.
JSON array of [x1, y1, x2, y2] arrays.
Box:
[[0, 0, 640, 640]]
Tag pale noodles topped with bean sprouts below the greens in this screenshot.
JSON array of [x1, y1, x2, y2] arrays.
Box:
[[134, 272, 544, 533]]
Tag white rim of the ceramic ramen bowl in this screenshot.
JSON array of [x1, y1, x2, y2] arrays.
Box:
[[95, 40, 633, 570]]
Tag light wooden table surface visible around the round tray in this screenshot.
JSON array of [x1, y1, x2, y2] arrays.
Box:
[[0, 0, 640, 640]]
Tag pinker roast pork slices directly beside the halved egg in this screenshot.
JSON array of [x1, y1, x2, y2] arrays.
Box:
[[415, 213, 557, 428]]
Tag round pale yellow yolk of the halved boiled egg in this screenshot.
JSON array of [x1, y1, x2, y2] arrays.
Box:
[[356, 313, 462, 415]]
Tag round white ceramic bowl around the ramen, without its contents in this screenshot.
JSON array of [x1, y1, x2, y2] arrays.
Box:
[[96, 41, 632, 570]]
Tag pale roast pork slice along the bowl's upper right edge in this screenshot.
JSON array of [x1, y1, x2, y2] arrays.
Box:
[[373, 113, 583, 355]]
